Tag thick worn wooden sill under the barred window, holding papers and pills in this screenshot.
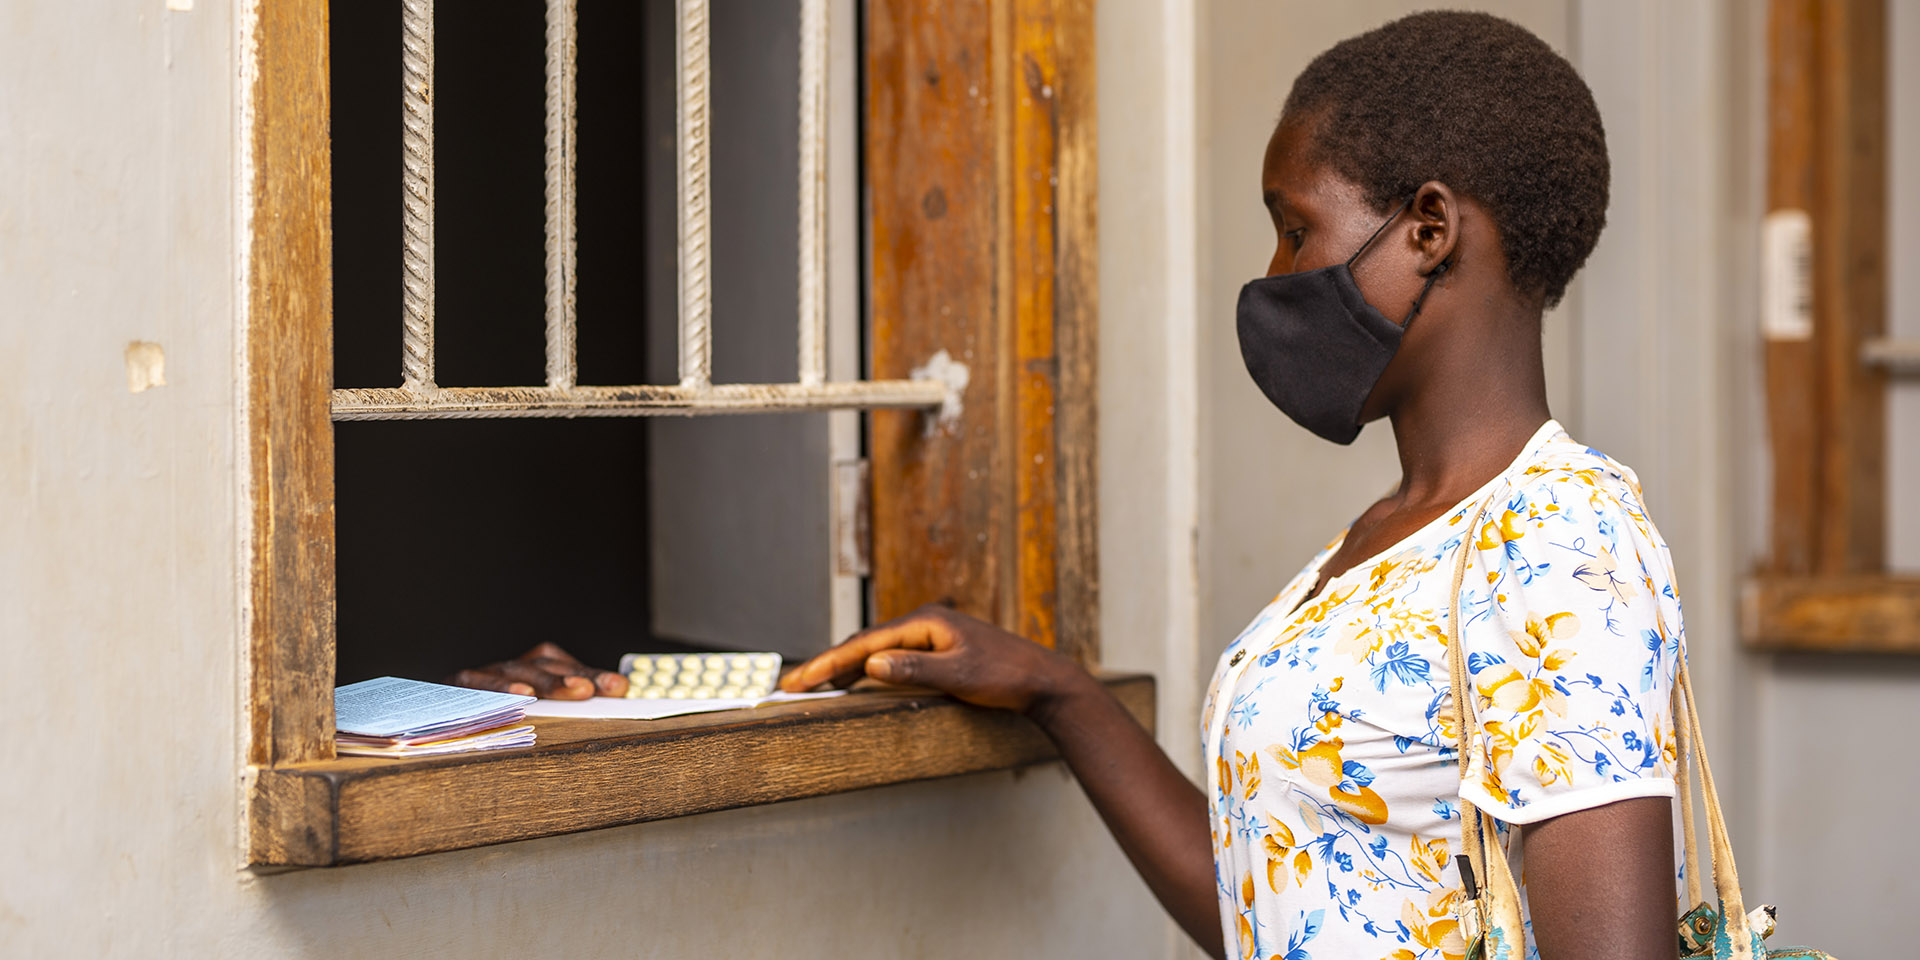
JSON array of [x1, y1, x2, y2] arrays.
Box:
[[248, 674, 1154, 866]]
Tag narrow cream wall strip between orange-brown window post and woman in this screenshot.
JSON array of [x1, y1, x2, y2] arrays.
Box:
[[1098, 0, 1202, 958]]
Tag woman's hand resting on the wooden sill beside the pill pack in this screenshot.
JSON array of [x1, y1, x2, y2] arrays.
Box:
[[780, 605, 1089, 712]]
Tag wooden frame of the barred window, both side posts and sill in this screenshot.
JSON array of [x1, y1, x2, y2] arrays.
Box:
[[240, 0, 1121, 868]]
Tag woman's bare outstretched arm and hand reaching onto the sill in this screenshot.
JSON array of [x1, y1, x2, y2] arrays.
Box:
[[781, 607, 1225, 956]]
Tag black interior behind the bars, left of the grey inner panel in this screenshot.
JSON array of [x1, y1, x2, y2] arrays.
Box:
[[332, 0, 678, 684]]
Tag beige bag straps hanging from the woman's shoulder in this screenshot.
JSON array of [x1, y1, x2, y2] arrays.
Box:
[[1448, 488, 1764, 960]]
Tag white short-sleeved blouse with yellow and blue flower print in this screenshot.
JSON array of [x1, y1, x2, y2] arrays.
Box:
[[1204, 420, 1682, 960]]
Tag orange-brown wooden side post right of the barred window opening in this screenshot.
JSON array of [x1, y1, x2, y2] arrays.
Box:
[[866, 0, 1098, 664]]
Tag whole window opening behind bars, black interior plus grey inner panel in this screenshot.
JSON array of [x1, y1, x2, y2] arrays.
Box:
[[330, 0, 829, 684]]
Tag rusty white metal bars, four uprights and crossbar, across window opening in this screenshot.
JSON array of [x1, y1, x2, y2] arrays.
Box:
[[332, 0, 952, 420]]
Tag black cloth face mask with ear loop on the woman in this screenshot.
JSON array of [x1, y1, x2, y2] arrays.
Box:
[[1235, 198, 1450, 444]]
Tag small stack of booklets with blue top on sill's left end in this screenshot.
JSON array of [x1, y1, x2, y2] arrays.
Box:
[[334, 676, 534, 756]]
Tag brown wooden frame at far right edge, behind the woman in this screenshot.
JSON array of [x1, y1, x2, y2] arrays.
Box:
[[1743, 0, 1920, 653]]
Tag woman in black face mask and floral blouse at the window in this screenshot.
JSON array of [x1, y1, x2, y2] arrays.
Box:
[[783, 13, 1682, 960]]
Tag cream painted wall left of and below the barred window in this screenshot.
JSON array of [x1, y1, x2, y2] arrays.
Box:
[[0, 0, 1167, 960]]
